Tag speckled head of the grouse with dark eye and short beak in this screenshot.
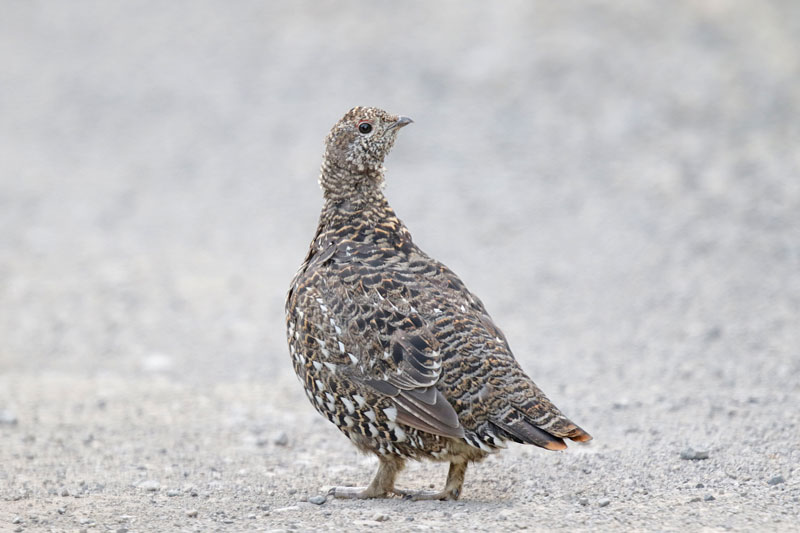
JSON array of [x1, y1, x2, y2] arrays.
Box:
[[320, 107, 413, 200]]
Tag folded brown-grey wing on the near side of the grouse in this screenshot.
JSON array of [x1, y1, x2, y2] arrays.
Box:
[[316, 242, 464, 438]]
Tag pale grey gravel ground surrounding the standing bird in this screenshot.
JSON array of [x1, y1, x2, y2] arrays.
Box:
[[0, 1, 800, 532]]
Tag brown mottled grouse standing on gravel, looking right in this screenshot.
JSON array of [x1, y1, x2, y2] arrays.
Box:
[[285, 106, 592, 500]]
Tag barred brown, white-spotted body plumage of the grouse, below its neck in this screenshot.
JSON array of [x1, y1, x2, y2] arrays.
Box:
[[286, 199, 585, 460]]
